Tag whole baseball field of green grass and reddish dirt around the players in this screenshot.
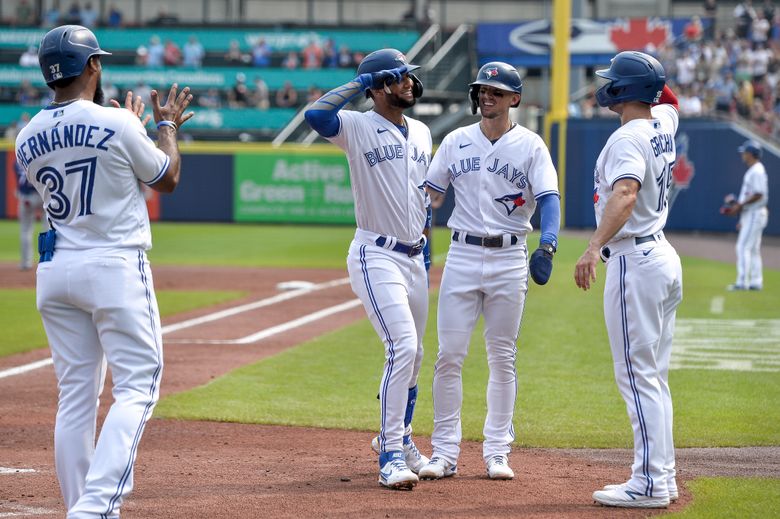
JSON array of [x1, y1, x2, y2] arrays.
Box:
[[0, 221, 780, 518]]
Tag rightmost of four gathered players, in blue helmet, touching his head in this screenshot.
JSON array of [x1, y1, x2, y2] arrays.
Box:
[[574, 52, 682, 508]]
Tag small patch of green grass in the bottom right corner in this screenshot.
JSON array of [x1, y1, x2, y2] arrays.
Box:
[[665, 478, 780, 519]]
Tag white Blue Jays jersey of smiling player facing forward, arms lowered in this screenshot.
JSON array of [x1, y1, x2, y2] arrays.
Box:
[[426, 123, 558, 236]]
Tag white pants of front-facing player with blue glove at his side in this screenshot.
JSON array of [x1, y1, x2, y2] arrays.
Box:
[[431, 239, 528, 464]]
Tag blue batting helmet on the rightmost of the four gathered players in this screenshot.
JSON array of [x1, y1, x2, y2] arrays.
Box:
[[596, 51, 666, 106]]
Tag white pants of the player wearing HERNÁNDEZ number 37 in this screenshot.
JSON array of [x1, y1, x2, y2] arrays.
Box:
[[37, 249, 163, 519]]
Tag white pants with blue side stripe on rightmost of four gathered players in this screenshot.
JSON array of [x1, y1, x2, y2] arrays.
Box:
[[604, 238, 682, 497]]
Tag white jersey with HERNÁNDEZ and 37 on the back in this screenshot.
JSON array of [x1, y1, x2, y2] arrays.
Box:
[[16, 100, 170, 250]]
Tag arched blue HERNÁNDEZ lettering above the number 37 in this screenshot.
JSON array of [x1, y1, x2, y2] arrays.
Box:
[[16, 124, 116, 169]]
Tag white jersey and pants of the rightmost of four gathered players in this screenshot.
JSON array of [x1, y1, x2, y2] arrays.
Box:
[[594, 104, 683, 504]]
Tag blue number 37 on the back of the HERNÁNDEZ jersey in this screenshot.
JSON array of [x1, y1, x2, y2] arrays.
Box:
[[35, 157, 97, 220]]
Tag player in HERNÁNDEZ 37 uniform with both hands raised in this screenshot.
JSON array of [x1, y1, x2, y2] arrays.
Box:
[[16, 25, 192, 519]]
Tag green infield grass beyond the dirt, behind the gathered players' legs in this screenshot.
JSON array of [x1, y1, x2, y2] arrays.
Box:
[[157, 232, 780, 447]]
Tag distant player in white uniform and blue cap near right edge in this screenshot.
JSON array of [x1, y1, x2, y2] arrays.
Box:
[[724, 140, 769, 290]]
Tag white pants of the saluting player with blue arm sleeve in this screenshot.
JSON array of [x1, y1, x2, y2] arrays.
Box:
[[347, 230, 428, 452]]
